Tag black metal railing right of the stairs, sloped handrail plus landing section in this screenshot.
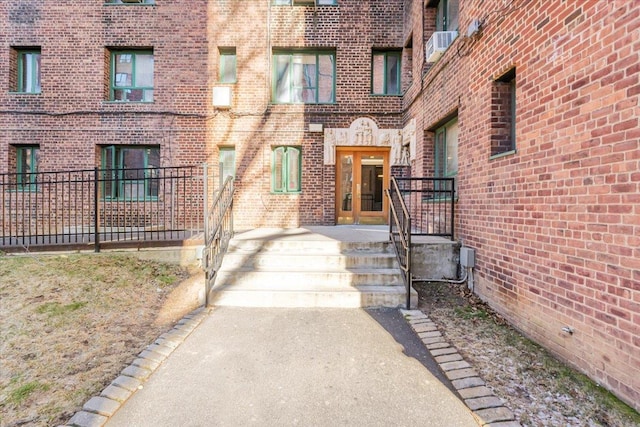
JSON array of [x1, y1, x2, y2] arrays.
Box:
[[386, 177, 455, 310]]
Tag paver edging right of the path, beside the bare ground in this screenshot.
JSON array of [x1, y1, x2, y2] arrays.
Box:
[[401, 310, 521, 427]]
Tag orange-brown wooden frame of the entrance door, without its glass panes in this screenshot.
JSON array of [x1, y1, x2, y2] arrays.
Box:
[[335, 146, 391, 224]]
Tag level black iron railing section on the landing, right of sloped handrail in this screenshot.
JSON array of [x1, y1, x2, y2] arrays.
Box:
[[394, 178, 455, 240]]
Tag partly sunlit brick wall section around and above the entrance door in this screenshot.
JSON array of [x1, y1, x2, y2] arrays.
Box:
[[208, 0, 404, 228]]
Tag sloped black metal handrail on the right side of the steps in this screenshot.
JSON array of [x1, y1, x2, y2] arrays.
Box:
[[385, 177, 413, 310]]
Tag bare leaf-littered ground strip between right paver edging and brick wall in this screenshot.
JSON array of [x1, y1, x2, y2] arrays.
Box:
[[418, 283, 640, 427]]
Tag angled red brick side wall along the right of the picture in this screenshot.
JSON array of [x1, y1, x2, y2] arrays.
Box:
[[405, 0, 640, 409]]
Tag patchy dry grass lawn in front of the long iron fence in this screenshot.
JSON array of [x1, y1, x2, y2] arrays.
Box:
[[0, 253, 196, 426]]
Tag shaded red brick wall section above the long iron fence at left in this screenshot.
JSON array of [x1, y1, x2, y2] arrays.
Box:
[[0, 0, 212, 176]]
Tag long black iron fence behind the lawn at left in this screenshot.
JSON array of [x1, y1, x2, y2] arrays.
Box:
[[0, 166, 216, 251]]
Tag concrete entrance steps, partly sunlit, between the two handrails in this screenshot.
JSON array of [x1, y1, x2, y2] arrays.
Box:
[[209, 236, 417, 308]]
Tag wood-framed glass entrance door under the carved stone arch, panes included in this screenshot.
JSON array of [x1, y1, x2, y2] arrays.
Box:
[[336, 147, 389, 224]]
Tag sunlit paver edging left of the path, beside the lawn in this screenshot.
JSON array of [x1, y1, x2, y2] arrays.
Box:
[[67, 307, 210, 427]]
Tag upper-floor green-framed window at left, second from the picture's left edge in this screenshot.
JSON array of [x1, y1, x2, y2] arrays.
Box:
[[110, 50, 153, 102]]
